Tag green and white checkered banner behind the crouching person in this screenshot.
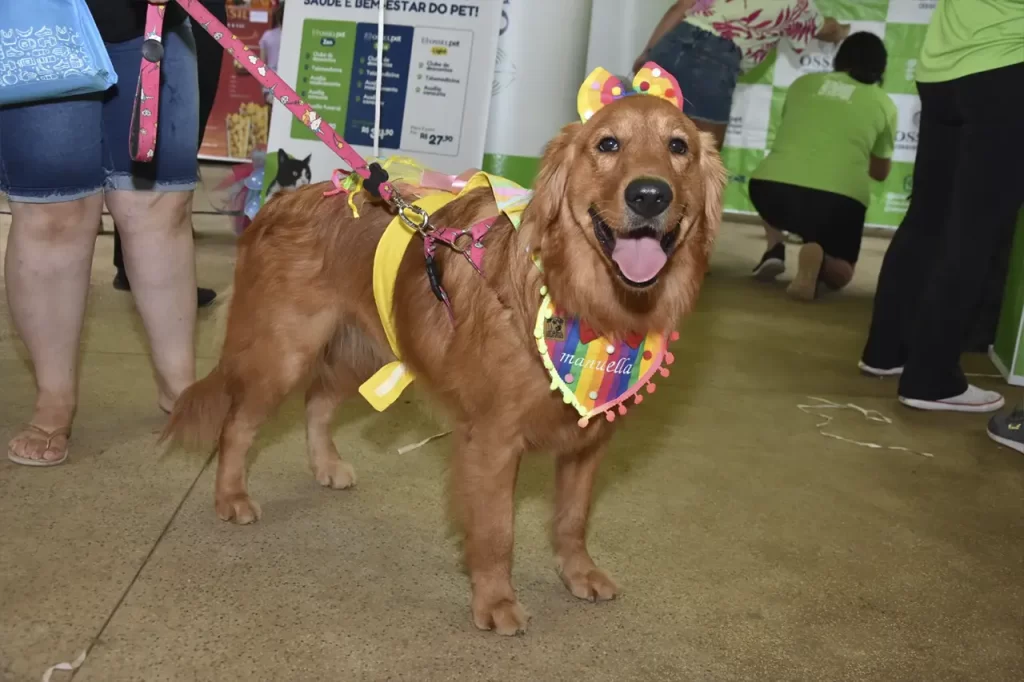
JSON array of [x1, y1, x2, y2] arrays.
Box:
[[723, 0, 938, 227]]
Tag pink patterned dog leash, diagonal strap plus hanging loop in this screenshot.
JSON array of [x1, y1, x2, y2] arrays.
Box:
[[132, 0, 395, 201]]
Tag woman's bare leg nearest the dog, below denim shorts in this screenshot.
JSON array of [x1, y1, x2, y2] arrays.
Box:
[[106, 190, 196, 411]]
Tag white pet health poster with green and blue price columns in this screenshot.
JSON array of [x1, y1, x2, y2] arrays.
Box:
[[264, 0, 502, 195]]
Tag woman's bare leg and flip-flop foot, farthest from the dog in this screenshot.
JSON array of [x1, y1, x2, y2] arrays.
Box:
[[4, 194, 103, 461]]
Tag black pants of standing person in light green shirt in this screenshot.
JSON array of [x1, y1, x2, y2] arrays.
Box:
[[863, 63, 1024, 400]]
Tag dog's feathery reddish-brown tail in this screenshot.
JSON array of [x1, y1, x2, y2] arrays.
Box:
[[160, 366, 231, 452]]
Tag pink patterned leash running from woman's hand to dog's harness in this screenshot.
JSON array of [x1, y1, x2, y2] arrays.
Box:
[[131, 0, 395, 201]]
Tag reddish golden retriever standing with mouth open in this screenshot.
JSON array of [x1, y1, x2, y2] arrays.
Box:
[[164, 90, 725, 635]]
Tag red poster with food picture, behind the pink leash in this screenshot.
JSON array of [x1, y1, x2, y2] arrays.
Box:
[[199, 0, 280, 163]]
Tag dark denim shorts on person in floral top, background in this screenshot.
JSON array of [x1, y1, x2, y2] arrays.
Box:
[[649, 22, 743, 123]]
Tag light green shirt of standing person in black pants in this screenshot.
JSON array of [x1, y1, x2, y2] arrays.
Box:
[[916, 0, 1024, 83]]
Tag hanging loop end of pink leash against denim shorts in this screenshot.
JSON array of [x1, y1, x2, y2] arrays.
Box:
[[128, 5, 166, 162]]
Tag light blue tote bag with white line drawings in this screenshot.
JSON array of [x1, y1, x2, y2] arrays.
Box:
[[0, 0, 118, 106]]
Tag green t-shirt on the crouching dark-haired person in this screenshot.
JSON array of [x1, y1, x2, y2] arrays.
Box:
[[753, 73, 896, 206]]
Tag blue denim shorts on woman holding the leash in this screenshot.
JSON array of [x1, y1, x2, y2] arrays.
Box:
[[0, 22, 199, 204]]
